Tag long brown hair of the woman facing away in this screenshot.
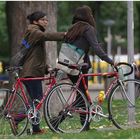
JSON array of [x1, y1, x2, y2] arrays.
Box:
[[65, 5, 95, 41]]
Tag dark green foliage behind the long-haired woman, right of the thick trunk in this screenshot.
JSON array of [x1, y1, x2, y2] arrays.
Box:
[[58, 1, 140, 54]]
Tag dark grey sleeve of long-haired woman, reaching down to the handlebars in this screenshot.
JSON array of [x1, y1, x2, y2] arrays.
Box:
[[84, 27, 114, 65]]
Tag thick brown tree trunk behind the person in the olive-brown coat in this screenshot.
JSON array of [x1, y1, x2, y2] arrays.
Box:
[[6, 1, 57, 67]]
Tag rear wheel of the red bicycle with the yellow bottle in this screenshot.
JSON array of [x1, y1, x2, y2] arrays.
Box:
[[44, 83, 89, 133]]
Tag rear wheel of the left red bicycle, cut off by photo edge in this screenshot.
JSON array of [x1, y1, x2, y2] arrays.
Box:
[[0, 89, 28, 138]]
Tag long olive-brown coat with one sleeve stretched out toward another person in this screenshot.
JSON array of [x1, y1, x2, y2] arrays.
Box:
[[21, 24, 64, 77]]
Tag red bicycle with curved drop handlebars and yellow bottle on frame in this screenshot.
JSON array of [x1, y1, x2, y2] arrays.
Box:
[[44, 62, 140, 133]]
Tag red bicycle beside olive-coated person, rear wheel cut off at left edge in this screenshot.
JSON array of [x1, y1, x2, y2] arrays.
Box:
[[0, 67, 66, 138]]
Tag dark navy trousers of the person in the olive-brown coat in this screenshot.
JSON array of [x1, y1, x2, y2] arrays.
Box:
[[24, 80, 43, 132]]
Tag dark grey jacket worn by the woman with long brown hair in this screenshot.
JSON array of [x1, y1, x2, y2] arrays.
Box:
[[66, 21, 114, 66]]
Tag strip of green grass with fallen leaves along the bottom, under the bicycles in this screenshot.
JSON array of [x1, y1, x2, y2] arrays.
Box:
[[0, 119, 140, 139]]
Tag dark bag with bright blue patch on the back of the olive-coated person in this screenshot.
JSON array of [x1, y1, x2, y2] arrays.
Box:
[[11, 39, 31, 66]]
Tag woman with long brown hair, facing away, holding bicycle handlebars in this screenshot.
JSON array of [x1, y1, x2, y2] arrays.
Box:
[[65, 5, 114, 130]]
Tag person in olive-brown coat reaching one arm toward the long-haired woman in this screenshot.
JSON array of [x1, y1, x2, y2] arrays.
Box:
[[20, 11, 65, 134]]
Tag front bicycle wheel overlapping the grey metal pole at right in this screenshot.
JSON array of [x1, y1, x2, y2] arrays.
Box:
[[108, 79, 140, 129]]
